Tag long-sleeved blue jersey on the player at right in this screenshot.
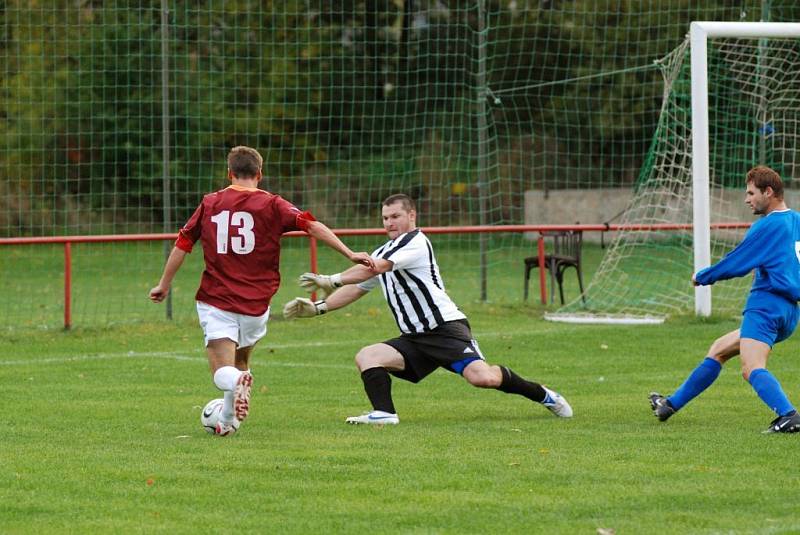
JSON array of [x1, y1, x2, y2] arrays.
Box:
[[695, 209, 800, 303]]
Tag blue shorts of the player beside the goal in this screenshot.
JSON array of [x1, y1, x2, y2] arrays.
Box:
[[739, 292, 800, 347]]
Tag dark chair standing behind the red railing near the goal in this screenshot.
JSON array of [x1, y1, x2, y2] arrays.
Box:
[[525, 230, 586, 305]]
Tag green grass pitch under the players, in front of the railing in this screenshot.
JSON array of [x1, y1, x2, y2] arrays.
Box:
[[0, 308, 800, 534]]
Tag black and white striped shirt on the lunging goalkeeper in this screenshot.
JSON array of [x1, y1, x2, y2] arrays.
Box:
[[358, 229, 466, 333]]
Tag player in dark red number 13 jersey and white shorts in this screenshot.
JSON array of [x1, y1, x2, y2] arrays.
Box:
[[150, 146, 375, 436]]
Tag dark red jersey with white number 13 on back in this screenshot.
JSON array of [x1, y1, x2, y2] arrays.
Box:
[[175, 185, 301, 316]]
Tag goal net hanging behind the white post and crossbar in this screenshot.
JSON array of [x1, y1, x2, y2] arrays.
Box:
[[550, 26, 800, 321]]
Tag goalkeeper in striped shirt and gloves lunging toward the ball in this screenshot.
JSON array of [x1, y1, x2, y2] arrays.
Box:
[[283, 194, 572, 424]]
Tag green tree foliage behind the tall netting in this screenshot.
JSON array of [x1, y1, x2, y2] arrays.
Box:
[[0, 0, 800, 234]]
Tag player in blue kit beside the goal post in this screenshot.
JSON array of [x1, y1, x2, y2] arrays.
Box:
[[650, 166, 800, 433]]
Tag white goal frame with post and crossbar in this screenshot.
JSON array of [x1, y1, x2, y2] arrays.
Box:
[[689, 21, 800, 316]]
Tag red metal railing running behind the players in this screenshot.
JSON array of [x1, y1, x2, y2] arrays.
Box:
[[0, 223, 750, 329]]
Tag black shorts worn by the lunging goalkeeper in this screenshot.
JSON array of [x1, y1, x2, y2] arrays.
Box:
[[384, 320, 485, 383]]
